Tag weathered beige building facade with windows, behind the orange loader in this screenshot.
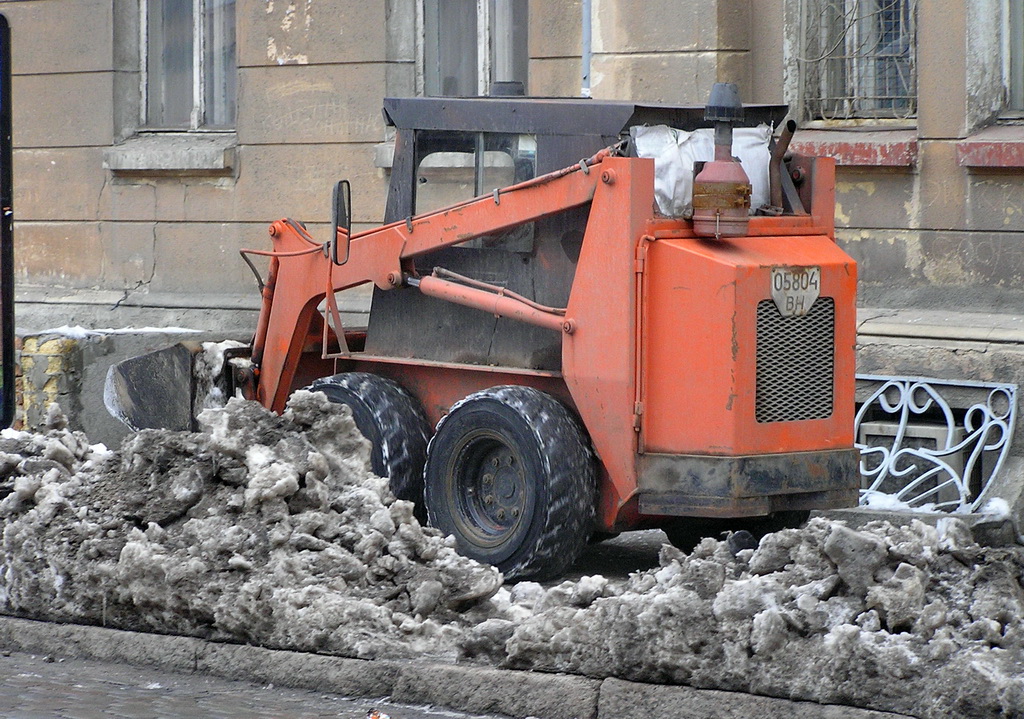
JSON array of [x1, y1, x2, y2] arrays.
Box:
[[0, 0, 1024, 438]]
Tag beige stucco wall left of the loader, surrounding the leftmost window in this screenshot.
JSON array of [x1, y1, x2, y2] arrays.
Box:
[[7, 0, 403, 317]]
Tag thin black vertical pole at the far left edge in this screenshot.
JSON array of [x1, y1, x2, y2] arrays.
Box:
[[0, 15, 15, 434]]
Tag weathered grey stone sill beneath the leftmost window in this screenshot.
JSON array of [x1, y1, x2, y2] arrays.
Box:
[[103, 132, 238, 175]]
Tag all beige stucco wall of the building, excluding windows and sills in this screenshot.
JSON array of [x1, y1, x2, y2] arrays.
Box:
[[6, 0, 1024, 327]]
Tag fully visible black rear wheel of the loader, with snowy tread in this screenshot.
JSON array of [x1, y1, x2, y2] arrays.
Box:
[[425, 385, 597, 580]]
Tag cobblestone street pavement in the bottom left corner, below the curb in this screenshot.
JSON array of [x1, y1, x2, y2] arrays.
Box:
[[0, 652, 496, 719]]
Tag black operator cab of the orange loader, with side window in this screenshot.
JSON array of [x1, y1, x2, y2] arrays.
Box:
[[366, 97, 786, 371]]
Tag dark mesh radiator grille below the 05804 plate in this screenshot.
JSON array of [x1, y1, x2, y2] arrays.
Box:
[[755, 297, 836, 422]]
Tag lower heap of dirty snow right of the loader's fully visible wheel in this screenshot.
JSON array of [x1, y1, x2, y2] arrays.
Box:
[[504, 517, 1024, 717]]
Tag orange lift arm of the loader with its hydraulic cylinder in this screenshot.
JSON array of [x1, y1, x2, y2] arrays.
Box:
[[249, 147, 616, 412]]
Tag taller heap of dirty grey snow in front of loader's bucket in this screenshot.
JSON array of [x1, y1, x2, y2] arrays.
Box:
[[0, 392, 501, 658]]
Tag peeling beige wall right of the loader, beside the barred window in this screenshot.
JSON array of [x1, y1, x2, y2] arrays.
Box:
[[837, 0, 1024, 312]]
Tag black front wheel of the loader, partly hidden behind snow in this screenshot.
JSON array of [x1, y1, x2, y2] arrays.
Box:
[[308, 372, 430, 519]]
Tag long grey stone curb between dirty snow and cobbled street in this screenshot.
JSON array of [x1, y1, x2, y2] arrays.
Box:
[[0, 617, 903, 719]]
